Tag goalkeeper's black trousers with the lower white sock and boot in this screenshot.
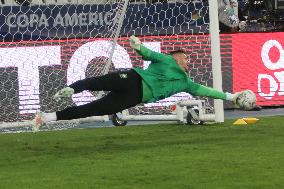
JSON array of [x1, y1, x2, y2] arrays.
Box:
[[34, 70, 142, 128]]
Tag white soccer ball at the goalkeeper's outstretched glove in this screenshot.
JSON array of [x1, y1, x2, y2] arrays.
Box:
[[237, 90, 256, 110]]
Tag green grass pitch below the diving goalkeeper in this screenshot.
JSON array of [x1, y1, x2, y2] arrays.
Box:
[[0, 116, 284, 189]]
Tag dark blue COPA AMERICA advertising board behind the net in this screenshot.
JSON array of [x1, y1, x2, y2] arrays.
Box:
[[0, 2, 209, 41]]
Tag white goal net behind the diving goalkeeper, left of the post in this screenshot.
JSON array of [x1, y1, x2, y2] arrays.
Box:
[[0, 0, 227, 132]]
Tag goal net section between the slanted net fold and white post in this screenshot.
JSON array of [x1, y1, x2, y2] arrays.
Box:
[[124, 1, 213, 114]]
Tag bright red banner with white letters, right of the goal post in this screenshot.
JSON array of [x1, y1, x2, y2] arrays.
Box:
[[232, 32, 284, 106]]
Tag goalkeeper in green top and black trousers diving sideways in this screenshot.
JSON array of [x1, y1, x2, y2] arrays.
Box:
[[34, 36, 248, 128]]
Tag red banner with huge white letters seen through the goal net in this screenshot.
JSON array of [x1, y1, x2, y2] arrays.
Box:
[[0, 35, 216, 121]]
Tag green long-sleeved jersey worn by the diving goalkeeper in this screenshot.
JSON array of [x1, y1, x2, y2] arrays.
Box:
[[134, 45, 226, 103]]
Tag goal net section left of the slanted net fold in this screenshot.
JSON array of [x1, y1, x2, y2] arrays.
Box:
[[0, 1, 131, 131]]
